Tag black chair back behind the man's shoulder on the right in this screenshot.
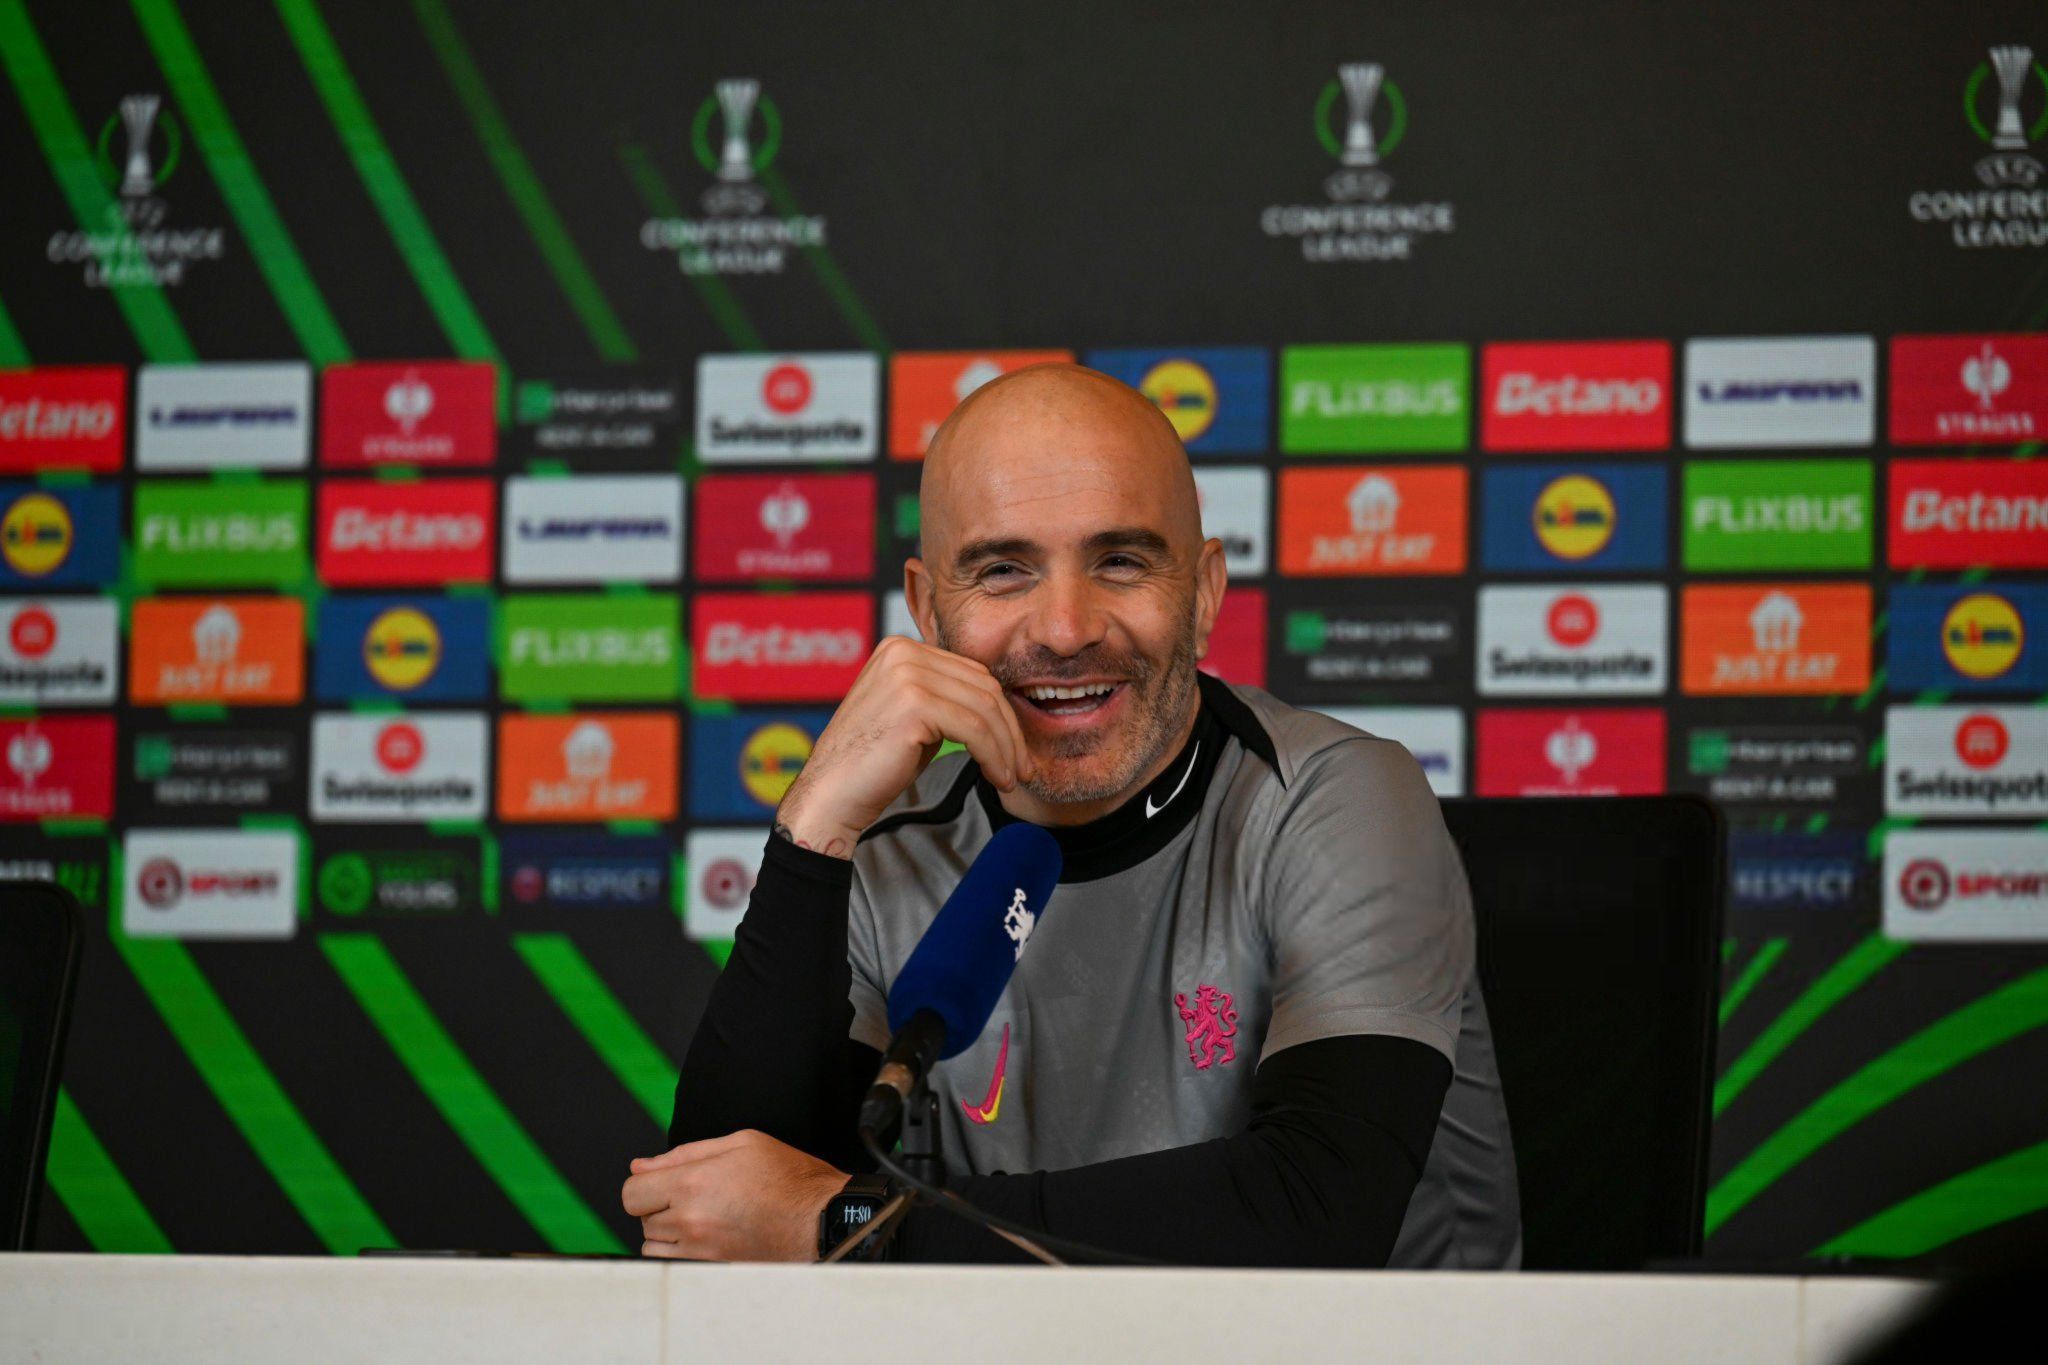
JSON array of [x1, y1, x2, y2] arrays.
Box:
[[1444, 796, 1726, 1271]]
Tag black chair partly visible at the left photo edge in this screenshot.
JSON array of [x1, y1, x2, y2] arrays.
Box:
[[0, 882, 84, 1250]]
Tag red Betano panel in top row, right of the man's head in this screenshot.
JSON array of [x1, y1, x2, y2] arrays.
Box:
[[1479, 342, 1671, 450]]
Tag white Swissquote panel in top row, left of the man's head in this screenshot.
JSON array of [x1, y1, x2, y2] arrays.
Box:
[[696, 352, 883, 465]]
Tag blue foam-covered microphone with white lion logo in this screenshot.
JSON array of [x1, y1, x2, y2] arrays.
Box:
[[860, 825, 1061, 1136]]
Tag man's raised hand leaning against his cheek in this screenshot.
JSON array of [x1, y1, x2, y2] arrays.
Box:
[[776, 634, 1032, 857]]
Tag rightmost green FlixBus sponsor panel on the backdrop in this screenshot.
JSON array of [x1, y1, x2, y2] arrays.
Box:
[[1686, 460, 1876, 571]]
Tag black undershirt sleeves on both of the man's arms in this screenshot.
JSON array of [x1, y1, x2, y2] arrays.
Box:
[[670, 837, 1452, 1267]]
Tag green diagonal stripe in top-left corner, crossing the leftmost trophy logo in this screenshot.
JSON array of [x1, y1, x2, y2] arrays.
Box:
[[0, 0, 197, 360]]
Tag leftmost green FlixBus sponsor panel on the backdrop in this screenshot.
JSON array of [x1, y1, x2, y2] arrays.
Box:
[[135, 479, 307, 587]]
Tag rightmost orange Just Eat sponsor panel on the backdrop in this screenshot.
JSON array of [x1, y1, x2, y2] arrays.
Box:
[[1679, 583, 1870, 696]]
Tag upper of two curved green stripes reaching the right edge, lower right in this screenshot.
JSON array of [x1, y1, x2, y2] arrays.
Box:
[[1706, 970, 2048, 1234]]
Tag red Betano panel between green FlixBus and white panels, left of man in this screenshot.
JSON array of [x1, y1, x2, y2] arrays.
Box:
[[319, 479, 498, 587]]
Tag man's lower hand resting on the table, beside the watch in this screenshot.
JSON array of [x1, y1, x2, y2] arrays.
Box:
[[621, 1130, 846, 1261]]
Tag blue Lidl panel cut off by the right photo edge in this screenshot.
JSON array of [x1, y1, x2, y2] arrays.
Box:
[[1884, 581, 2048, 692]]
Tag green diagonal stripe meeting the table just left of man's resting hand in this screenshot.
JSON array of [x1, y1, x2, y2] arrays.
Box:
[[319, 933, 625, 1252]]
